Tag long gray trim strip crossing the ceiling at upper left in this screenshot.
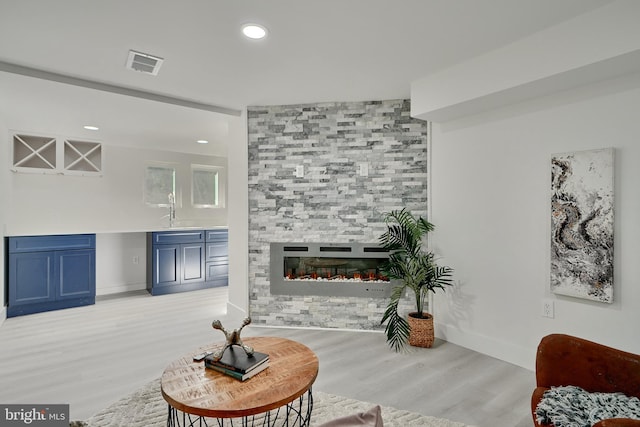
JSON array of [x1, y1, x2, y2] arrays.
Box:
[[0, 61, 242, 117]]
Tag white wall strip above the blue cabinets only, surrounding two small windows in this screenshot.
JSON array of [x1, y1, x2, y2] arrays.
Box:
[[4, 145, 227, 235]]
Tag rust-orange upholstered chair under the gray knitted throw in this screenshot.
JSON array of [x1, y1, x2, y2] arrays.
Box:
[[531, 334, 640, 427]]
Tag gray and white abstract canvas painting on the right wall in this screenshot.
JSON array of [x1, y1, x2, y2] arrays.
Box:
[[551, 148, 614, 303]]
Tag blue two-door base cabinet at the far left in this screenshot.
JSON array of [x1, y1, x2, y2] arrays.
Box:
[[6, 234, 96, 317]]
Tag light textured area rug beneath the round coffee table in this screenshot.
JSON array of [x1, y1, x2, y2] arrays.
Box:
[[77, 379, 470, 427]]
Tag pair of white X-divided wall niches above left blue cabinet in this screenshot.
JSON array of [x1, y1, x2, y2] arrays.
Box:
[[11, 133, 102, 176]]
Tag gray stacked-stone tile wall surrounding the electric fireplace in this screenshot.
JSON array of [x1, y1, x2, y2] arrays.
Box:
[[248, 100, 428, 329]]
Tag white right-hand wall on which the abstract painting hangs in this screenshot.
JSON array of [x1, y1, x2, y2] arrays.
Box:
[[431, 74, 640, 369]]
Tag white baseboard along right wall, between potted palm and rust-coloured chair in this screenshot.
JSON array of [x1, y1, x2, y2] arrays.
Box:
[[435, 322, 536, 371]]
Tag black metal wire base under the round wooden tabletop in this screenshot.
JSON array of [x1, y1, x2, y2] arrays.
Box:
[[167, 389, 313, 427]]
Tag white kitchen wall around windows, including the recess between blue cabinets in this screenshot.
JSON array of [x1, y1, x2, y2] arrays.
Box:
[[0, 143, 227, 295]]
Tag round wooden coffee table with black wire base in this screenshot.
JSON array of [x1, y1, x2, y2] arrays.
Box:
[[161, 337, 318, 427]]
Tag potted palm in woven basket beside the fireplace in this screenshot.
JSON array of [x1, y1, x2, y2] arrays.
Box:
[[379, 209, 453, 351]]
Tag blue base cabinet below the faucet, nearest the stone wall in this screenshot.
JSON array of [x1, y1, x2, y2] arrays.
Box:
[[147, 230, 228, 295]]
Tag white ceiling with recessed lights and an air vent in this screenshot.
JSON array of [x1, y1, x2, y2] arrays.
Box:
[[0, 0, 612, 153]]
